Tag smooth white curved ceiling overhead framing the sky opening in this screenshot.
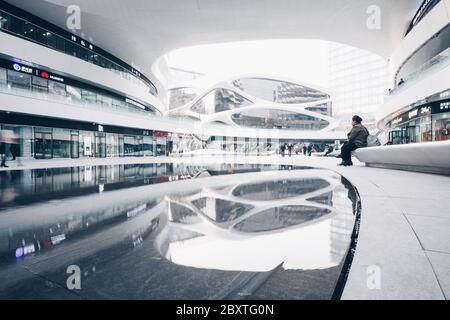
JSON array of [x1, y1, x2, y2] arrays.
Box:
[[7, 0, 422, 90]]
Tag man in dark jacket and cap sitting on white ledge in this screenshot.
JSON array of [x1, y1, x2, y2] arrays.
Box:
[[339, 116, 369, 167]]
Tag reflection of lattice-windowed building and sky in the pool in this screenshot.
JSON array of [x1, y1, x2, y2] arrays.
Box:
[[157, 170, 355, 272]]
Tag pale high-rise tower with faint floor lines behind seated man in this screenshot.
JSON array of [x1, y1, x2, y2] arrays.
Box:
[[329, 43, 389, 129]]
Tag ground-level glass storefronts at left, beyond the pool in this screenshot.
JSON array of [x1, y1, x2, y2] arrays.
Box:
[[0, 113, 154, 159]]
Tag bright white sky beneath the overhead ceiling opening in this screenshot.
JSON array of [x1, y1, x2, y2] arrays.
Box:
[[167, 40, 330, 88]]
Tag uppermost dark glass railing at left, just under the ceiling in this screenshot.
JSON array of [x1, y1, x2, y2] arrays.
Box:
[[0, 10, 158, 96]]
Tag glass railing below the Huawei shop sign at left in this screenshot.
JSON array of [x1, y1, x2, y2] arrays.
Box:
[[0, 83, 155, 118]]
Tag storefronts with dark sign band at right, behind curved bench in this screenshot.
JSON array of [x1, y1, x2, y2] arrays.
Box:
[[387, 94, 450, 144]]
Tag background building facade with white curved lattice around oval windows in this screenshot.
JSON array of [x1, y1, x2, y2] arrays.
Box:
[[170, 77, 335, 131]]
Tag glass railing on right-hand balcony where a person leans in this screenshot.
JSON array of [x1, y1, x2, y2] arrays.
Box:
[[388, 48, 450, 99]]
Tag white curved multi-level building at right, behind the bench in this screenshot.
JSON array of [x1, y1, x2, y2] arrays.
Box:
[[377, 0, 450, 150]]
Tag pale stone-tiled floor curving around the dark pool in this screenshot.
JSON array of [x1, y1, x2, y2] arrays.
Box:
[[0, 156, 450, 300]]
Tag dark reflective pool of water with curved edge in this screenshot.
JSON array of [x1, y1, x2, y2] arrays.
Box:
[[0, 164, 360, 299]]
